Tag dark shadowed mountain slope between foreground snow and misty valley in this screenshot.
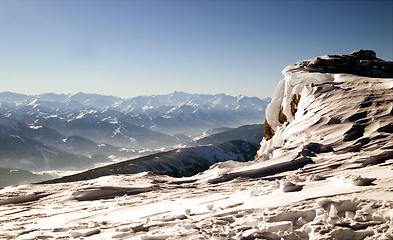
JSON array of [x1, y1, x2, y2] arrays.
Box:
[[39, 140, 257, 183]]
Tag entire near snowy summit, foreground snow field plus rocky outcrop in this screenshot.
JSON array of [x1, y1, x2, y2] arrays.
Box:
[[0, 51, 393, 240]]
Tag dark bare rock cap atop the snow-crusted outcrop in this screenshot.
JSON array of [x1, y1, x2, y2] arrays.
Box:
[[296, 50, 393, 78]]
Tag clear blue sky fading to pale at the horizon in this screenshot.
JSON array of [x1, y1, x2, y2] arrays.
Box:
[[0, 0, 393, 98]]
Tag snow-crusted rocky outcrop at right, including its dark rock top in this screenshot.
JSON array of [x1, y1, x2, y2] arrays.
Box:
[[258, 50, 393, 160]]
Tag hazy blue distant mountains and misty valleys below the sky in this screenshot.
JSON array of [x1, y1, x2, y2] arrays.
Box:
[[0, 92, 270, 176]]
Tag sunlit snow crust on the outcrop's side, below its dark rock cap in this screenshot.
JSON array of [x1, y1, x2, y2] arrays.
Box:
[[259, 73, 392, 159]]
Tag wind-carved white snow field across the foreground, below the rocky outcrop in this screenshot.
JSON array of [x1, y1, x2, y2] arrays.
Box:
[[0, 166, 393, 240]]
